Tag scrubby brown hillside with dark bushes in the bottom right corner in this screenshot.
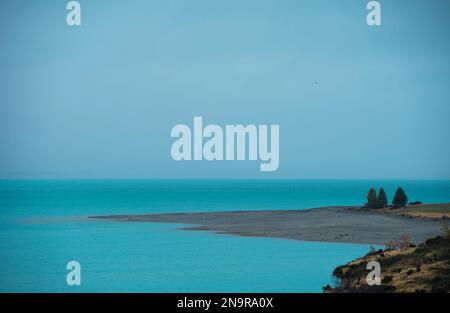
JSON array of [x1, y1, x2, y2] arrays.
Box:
[[324, 232, 450, 293]]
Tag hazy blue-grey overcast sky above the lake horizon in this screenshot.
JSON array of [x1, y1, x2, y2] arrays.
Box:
[[0, 0, 450, 179]]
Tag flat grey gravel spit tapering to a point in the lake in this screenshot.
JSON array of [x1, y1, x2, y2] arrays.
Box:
[[92, 207, 444, 245]]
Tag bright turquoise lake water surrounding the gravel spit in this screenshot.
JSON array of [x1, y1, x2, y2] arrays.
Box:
[[0, 180, 450, 292]]
